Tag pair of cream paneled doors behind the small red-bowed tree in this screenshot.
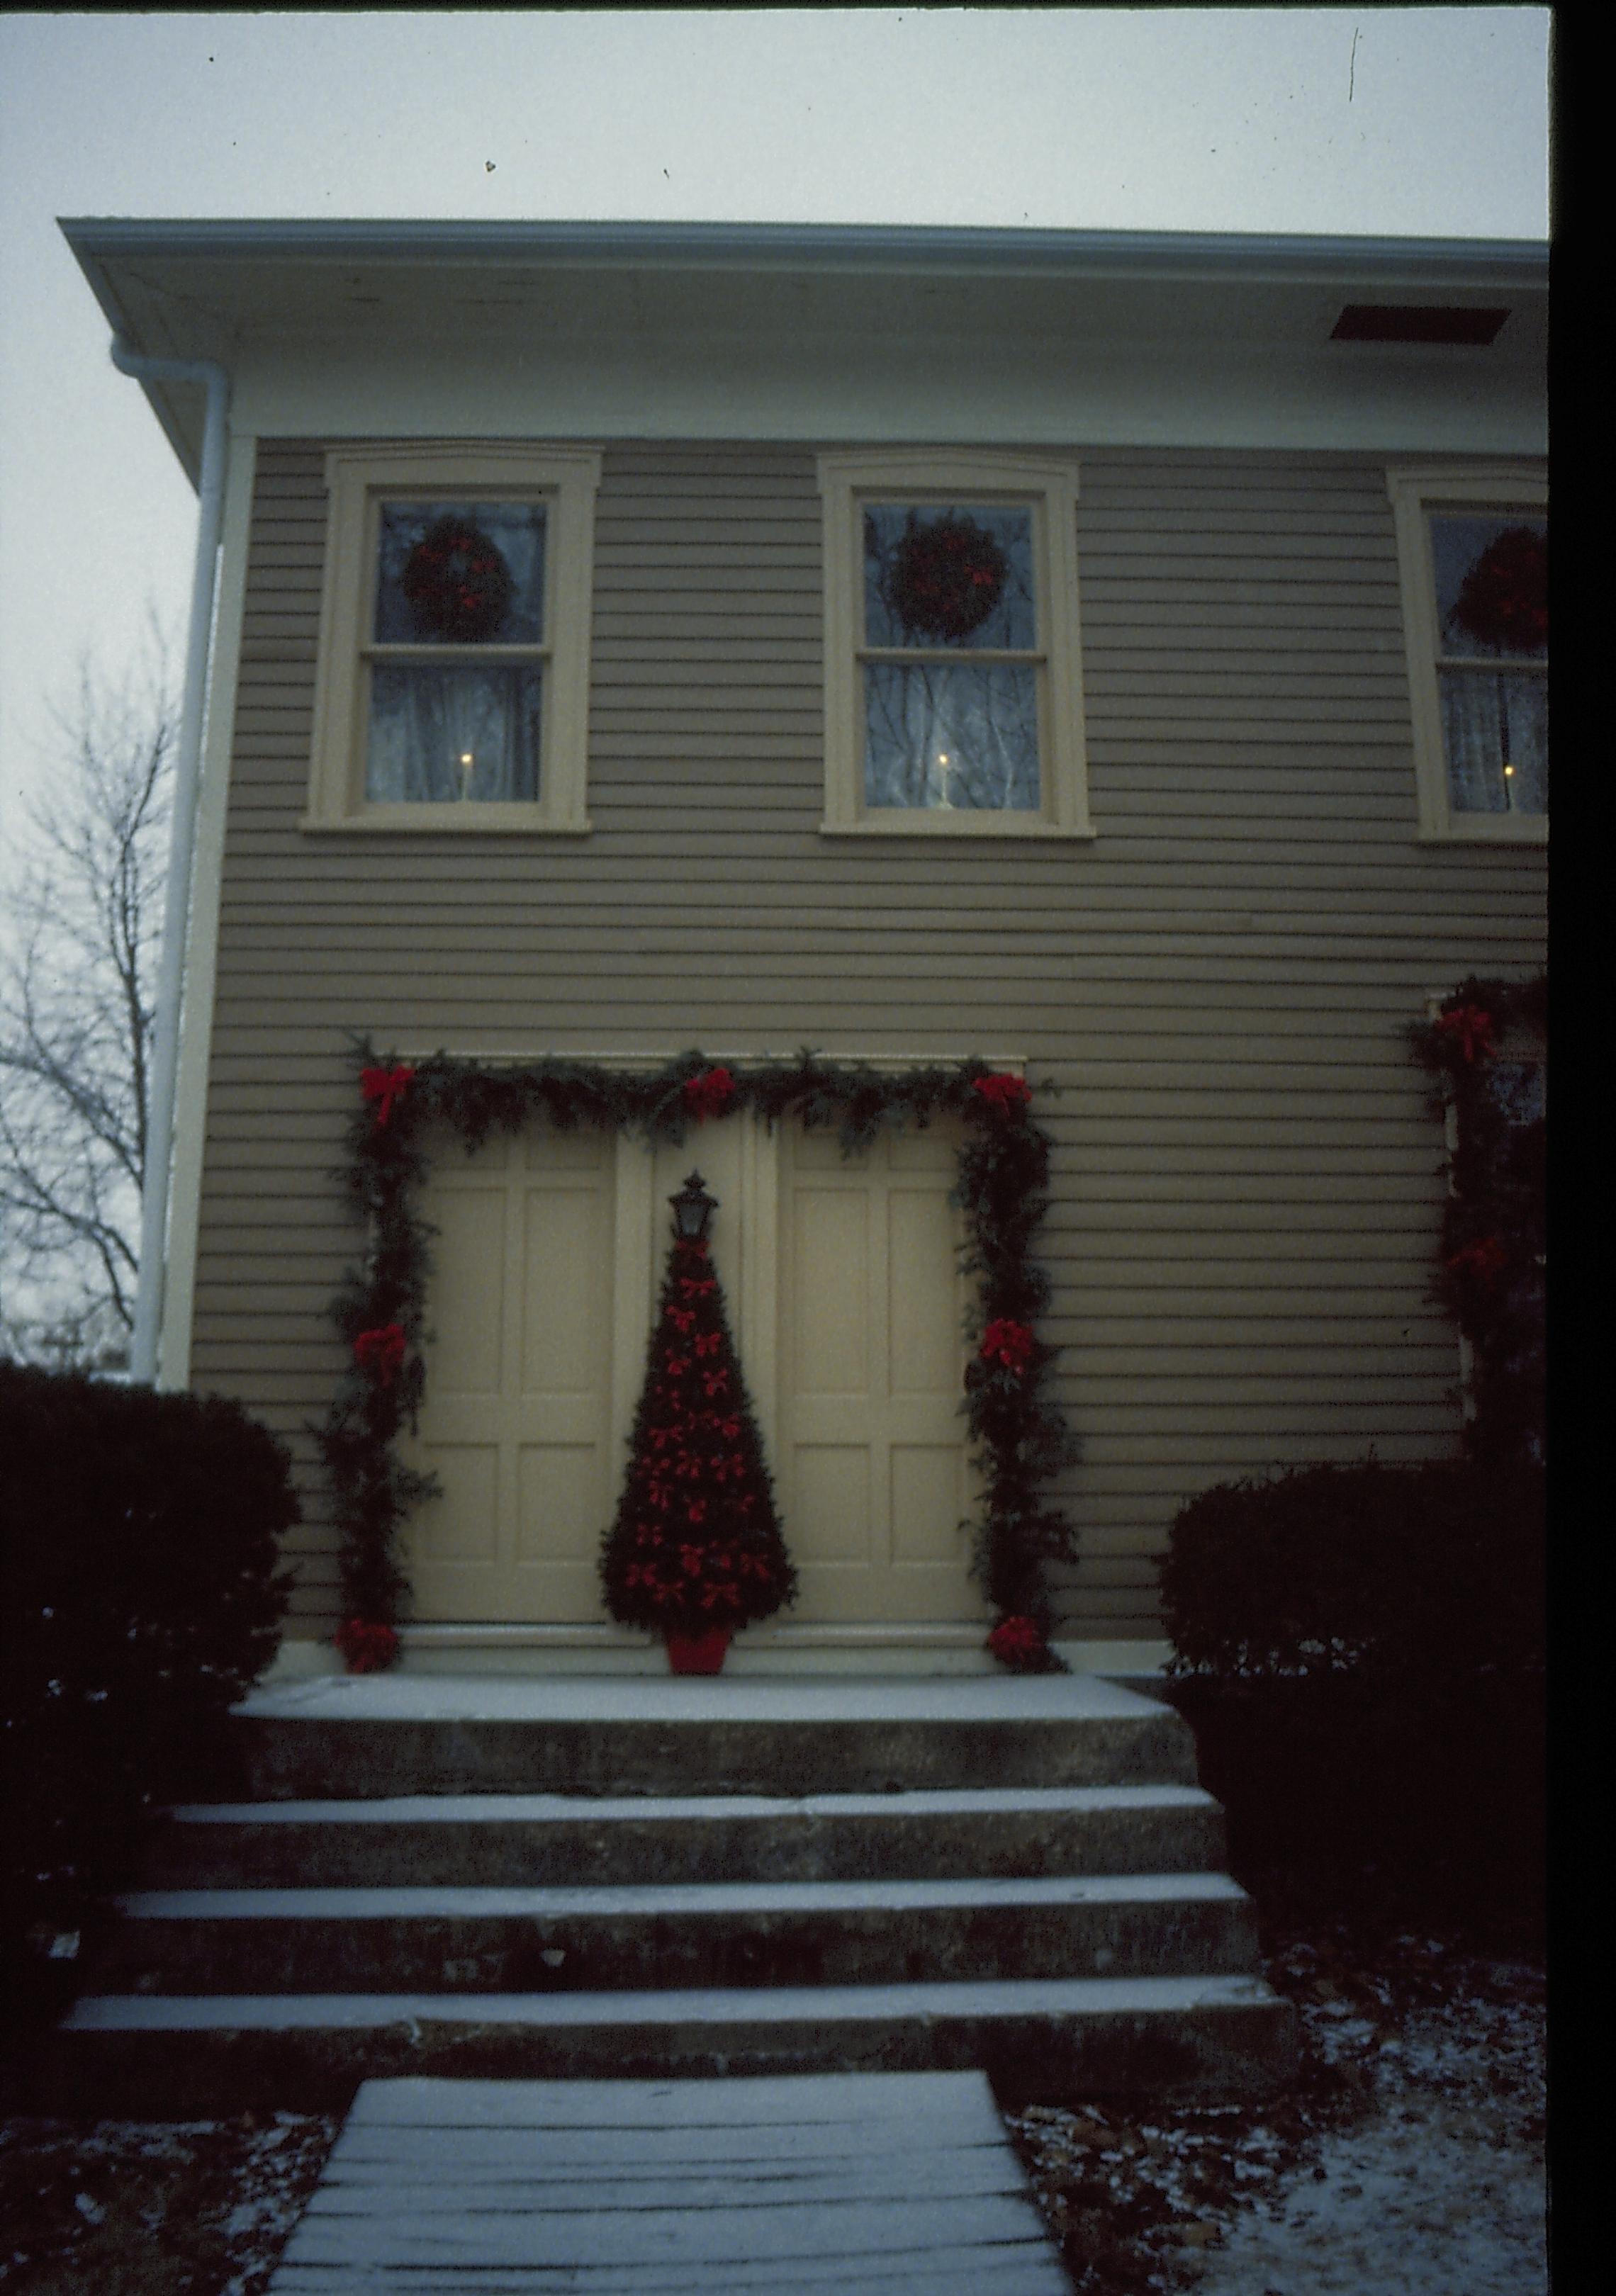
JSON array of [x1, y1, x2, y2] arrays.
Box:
[[408, 1118, 982, 1626]]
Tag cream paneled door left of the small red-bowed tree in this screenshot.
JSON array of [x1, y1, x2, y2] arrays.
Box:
[[406, 1132, 617, 1621]]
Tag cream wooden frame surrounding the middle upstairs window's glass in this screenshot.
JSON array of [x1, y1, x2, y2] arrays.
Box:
[[819, 450, 1095, 838]]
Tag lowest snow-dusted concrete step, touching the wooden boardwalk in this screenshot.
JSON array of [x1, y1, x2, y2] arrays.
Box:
[[47, 1974, 1295, 2117]]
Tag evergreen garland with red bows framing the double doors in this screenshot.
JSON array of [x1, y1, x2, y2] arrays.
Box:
[[319, 1045, 1079, 1672]]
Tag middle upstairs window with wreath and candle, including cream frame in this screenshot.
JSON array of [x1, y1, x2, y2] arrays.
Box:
[[819, 452, 1090, 835]]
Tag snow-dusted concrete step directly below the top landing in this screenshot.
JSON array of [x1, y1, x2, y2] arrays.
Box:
[[145, 1786, 1225, 1890]]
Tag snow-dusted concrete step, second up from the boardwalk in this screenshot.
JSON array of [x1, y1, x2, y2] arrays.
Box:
[[89, 1874, 1256, 1993]]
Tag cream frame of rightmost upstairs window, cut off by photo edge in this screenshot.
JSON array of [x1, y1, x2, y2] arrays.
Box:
[[1386, 463, 1549, 845]]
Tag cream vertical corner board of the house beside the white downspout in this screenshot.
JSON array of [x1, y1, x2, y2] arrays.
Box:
[[156, 432, 257, 1389]]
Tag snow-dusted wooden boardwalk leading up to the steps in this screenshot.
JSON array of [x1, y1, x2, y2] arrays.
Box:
[[271, 2073, 1072, 2296]]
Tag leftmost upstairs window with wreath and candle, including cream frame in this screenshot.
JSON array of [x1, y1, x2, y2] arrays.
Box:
[[308, 446, 599, 831]]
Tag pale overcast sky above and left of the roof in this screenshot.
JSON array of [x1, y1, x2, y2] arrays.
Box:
[[0, 7, 1549, 835]]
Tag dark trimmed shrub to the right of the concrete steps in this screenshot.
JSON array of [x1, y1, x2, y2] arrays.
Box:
[[1162, 1461, 1545, 1917]]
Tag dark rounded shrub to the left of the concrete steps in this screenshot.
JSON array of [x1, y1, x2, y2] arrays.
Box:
[[0, 1364, 298, 2009]]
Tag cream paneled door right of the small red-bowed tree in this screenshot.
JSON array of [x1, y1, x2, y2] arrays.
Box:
[[773, 1130, 984, 1626]]
